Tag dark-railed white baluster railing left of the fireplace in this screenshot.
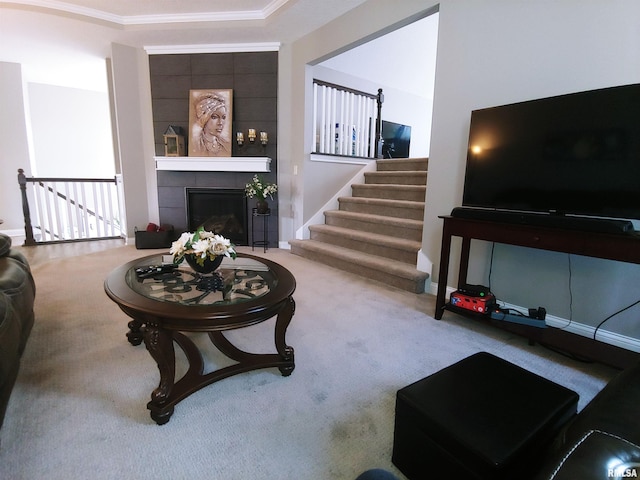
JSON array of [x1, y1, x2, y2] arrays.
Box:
[[18, 169, 125, 245]]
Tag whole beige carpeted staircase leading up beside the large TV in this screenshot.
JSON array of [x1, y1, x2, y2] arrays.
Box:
[[289, 158, 429, 293]]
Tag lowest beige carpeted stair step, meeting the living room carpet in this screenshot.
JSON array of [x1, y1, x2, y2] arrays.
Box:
[[289, 240, 429, 293]]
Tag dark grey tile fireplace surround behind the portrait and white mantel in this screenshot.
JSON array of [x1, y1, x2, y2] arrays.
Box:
[[149, 52, 279, 248]]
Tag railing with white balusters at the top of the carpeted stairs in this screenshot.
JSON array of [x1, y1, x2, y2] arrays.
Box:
[[311, 80, 384, 158]]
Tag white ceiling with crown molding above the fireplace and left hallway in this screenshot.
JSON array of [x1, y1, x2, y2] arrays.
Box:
[[0, 0, 424, 90]]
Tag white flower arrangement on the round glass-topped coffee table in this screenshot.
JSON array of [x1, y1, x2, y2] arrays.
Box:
[[169, 227, 236, 265]]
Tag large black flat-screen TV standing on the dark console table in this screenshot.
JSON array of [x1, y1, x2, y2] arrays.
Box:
[[462, 84, 640, 219]]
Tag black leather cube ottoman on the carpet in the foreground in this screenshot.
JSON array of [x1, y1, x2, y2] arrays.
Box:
[[392, 352, 578, 480]]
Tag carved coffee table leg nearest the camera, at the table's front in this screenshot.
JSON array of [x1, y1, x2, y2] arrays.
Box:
[[144, 323, 176, 425]]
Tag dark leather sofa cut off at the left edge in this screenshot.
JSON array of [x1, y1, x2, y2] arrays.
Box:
[[0, 234, 36, 427]]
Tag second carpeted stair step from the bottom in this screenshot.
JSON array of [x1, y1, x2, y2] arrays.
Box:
[[309, 225, 421, 266]]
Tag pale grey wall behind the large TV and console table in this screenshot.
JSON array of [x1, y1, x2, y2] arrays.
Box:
[[423, 0, 640, 338]]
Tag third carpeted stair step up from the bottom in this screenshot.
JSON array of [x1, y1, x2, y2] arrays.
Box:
[[324, 210, 424, 242]]
